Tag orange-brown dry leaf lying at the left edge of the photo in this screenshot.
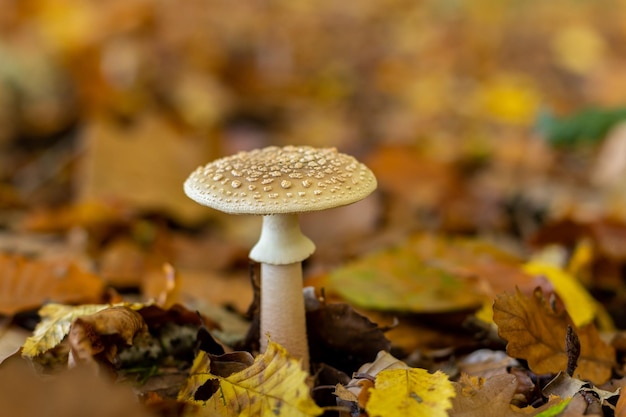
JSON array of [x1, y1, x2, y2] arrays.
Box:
[[0, 250, 104, 315]]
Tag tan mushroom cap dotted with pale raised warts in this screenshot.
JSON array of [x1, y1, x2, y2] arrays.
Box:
[[184, 146, 376, 215]]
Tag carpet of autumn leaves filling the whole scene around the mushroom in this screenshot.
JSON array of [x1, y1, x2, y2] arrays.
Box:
[[0, 0, 626, 417]]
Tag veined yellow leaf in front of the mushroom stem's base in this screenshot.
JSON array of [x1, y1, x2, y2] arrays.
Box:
[[178, 341, 323, 417]]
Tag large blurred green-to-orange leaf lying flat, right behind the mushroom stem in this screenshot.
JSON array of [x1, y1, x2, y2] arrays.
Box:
[[329, 234, 537, 313]]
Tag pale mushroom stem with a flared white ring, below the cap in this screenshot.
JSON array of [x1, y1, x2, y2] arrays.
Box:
[[250, 214, 315, 369]]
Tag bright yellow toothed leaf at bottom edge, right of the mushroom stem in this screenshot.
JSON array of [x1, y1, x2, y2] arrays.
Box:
[[365, 368, 455, 417]]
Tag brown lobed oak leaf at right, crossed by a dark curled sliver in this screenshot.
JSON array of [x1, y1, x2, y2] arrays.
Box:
[[493, 289, 615, 384]]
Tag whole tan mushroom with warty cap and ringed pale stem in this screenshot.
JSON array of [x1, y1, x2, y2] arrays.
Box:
[[184, 146, 376, 368]]
